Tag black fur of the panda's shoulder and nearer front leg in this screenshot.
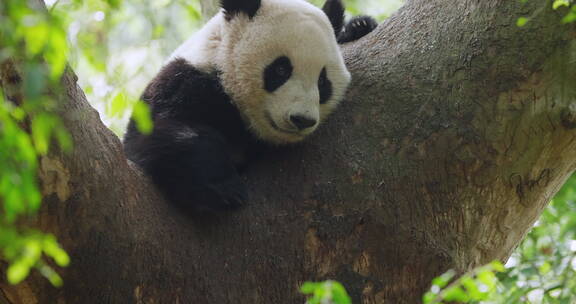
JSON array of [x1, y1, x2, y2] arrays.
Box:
[[124, 59, 260, 212]]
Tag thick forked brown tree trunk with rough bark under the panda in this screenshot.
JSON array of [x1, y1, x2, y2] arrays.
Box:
[[0, 0, 576, 303]]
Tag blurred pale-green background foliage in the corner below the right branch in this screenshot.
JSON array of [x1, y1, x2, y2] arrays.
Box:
[[492, 175, 576, 303]]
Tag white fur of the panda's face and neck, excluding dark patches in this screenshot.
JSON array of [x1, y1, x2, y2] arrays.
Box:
[[170, 0, 350, 144]]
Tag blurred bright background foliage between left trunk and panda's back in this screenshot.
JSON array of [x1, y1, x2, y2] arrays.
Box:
[[60, 0, 202, 135]]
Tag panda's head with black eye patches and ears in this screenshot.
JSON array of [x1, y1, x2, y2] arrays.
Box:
[[216, 0, 350, 144]]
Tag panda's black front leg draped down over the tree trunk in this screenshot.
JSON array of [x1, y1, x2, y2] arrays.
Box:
[[132, 121, 248, 213]]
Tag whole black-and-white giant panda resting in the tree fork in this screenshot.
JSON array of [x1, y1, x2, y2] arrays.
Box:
[[124, 0, 376, 212]]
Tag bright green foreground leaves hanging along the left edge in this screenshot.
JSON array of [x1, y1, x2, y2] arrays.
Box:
[[0, 0, 72, 286]]
